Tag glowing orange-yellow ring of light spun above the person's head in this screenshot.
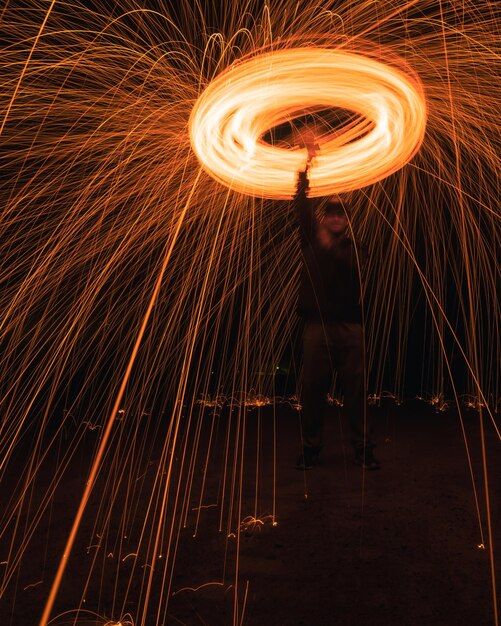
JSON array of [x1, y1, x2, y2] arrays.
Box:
[[190, 47, 426, 199]]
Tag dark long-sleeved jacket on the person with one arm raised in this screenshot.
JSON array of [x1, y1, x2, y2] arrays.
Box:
[[294, 172, 367, 323]]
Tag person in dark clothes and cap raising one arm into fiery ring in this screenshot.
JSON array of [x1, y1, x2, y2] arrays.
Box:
[[294, 160, 380, 470]]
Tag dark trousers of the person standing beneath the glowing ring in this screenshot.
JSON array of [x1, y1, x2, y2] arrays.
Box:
[[301, 319, 374, 449]]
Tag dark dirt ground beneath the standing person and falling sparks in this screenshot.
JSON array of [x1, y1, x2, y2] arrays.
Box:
[[0, 401, 501, 626]]
